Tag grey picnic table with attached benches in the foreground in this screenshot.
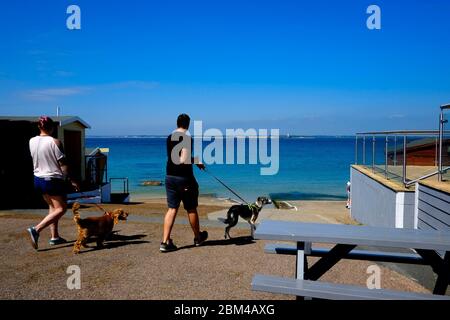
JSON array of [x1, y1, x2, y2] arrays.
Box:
[[252, 221, 450, 300]]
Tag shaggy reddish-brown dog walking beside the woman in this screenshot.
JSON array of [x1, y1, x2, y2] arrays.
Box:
[[72, 202, 128, 253]]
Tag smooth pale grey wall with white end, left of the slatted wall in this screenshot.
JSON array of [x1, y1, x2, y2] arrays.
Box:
[[350, 167, 415, 228]]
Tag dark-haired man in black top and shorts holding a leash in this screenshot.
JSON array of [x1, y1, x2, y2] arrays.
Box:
[[159, 114, 208, 252]]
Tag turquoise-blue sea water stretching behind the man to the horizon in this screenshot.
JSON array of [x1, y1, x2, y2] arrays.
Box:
[[86, 137, 355, 201]]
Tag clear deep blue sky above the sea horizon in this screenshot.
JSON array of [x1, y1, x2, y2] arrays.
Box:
[[0, 0, 450, 135]]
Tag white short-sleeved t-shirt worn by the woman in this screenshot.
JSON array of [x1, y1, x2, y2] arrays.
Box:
[[30, 136, 65, 179]]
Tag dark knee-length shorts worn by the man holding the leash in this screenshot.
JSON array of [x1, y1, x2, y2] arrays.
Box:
[[166, 175, 198, 211]]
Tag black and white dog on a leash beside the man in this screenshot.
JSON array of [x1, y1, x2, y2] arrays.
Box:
[[222, 197, 272, 239]]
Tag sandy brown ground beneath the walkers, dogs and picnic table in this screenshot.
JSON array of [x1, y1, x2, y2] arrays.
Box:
[[0, 198, 429, 300]]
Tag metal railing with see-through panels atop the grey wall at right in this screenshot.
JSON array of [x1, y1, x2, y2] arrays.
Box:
[[355, 104, 450, 187]]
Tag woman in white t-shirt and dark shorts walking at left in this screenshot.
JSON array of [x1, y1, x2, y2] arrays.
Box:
[[27, 117, 79, 250]]
